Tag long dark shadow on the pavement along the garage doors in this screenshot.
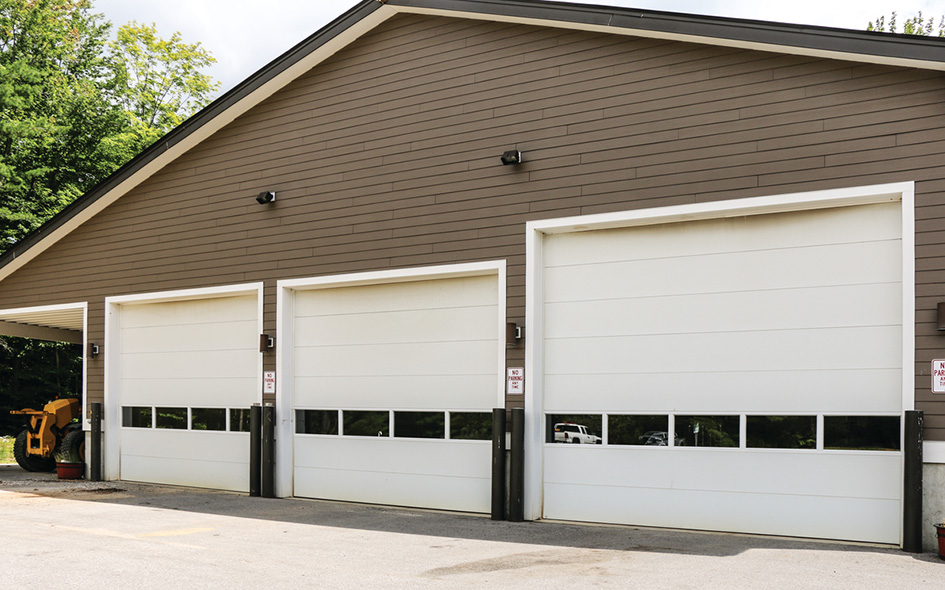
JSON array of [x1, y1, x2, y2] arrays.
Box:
[[0, 465, 939, 562]]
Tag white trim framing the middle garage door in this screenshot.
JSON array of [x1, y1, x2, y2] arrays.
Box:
[[275, 260, 506, 498]]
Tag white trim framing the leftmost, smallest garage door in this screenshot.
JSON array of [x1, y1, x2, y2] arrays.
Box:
[[102, 283, 263, 480]]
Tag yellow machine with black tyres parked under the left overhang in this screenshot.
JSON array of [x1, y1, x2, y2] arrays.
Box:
[[10, 398, 85, 471]]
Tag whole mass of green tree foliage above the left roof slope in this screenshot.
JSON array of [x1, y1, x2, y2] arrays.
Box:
[[0, 0, 218, 252]]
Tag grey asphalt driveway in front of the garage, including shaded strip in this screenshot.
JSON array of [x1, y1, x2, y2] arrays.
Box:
[[0, 466, 945, 590]]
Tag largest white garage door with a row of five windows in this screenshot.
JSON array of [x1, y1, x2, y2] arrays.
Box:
[[543, 203, 902, 543]]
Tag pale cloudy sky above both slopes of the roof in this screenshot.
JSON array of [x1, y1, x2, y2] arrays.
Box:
[[92, 0, 945, 93]]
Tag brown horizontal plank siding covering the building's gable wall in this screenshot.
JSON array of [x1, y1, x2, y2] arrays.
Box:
[[0, 16, 945, 440]]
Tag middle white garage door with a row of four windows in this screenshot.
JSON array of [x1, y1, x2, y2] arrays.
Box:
[[292, 274, 504, 512]]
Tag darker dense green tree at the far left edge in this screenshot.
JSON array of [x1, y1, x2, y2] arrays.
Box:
[[0, 0, 121, 249]]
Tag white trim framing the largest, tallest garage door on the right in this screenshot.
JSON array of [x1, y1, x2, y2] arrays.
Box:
[[524, 181, 915, 520]]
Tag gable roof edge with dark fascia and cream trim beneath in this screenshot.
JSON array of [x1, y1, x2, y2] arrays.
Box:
[[0, 0, 945, 280]]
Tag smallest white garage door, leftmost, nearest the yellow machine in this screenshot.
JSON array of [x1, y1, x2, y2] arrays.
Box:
[[119, 296, 260, 492]]
